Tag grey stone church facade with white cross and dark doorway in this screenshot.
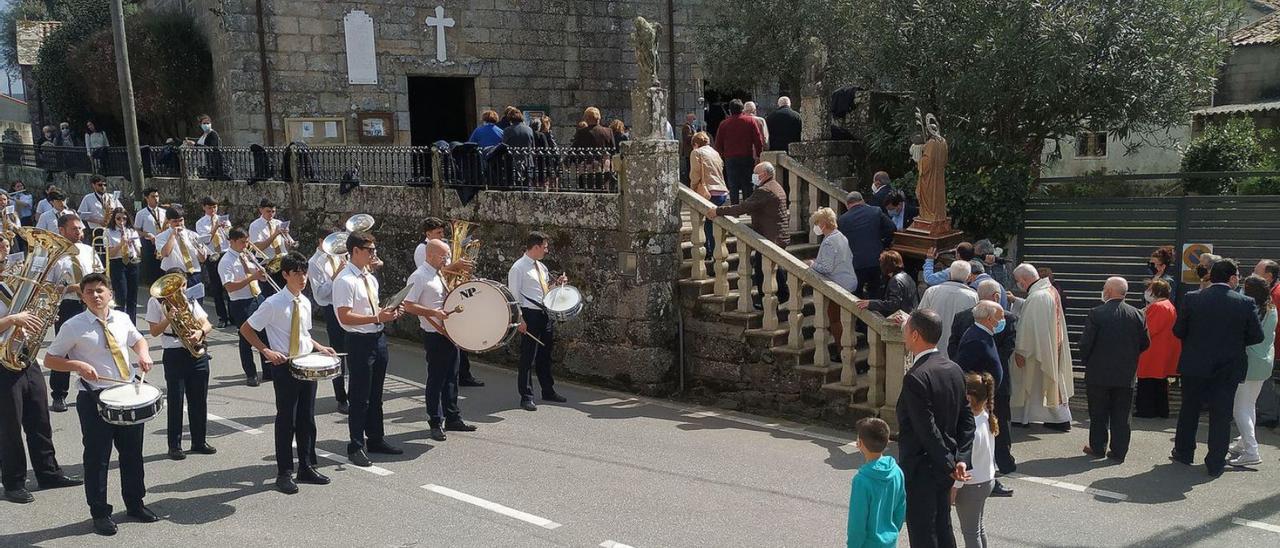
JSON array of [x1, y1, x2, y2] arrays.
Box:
[[151, 0, 701, 146]]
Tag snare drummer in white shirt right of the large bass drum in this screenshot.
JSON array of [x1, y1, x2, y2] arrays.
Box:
[[507, 232, 568, 411]]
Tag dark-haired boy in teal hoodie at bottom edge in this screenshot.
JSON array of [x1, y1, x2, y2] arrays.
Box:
[[849, 417, 906, 548]]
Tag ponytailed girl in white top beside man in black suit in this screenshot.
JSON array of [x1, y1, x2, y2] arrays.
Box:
[[951, 373, 1000, 548]]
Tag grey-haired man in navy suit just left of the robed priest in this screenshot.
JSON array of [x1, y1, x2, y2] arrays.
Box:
[[947, 279, 1018, 486]]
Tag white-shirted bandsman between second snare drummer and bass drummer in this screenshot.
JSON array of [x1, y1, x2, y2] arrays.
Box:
[[333, 232, 404, 466]]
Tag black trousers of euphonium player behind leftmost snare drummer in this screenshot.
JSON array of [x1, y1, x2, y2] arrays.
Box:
[[163, 348, 209, 449]]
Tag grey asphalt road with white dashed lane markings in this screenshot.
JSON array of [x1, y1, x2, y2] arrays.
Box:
[[0, 314, 1280, 547]]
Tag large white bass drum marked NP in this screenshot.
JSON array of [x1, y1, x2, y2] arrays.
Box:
[[444, 279, 521, 352]]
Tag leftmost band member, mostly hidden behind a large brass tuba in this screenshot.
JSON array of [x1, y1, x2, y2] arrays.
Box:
[[0, 238, 83, 504]]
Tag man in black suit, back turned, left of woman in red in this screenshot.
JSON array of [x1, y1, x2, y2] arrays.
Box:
[[1080, 277, 1151, 462]]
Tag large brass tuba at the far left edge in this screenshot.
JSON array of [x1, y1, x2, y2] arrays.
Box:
[[0, 227, 76, 371]]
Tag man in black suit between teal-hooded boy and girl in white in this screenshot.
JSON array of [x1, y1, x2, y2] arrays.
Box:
[[897, 309, 975, 548]]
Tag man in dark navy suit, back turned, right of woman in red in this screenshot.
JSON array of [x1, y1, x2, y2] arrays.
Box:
[[1169, 259, 1263, 478]]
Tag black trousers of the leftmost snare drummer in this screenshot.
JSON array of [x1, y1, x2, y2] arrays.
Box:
[[76, 391, 147, 517]]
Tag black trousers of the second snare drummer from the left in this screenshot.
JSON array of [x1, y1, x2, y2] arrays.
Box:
[[271, 365, 317, 474]]
